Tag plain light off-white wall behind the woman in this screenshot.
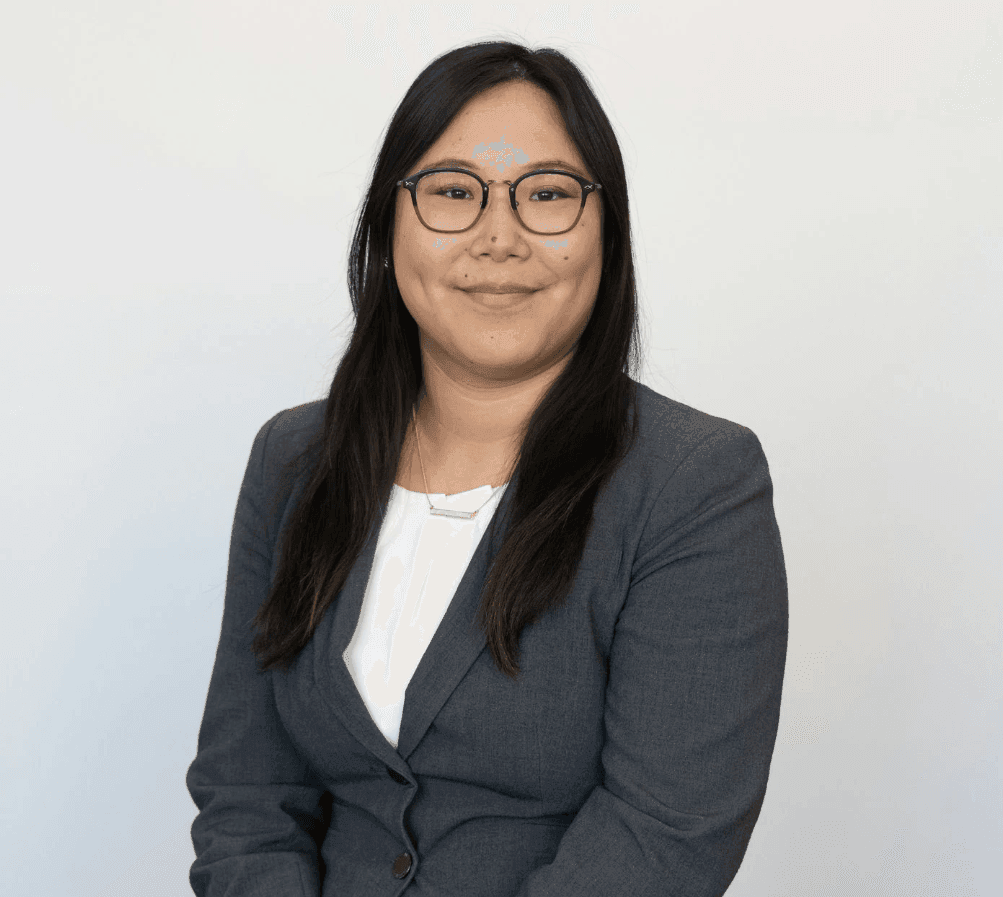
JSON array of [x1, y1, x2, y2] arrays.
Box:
[[0, 0, 1003, 897]]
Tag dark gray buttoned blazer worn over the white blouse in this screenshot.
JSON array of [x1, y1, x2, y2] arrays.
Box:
[[187, 384, 787, 897]]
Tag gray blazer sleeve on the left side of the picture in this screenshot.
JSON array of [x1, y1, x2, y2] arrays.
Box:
[[186, 412, 325, 897]]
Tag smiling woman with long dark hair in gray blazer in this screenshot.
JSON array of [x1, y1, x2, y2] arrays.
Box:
[[187, 38, 787, 897]]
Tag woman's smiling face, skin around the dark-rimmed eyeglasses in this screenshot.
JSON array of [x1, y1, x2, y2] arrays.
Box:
[[392, 81, 603, 386]]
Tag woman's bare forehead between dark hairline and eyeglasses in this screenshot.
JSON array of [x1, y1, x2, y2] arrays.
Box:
[[420, 81, 588, 175]]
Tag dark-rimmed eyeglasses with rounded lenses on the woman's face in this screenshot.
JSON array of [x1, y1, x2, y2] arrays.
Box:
[[397, 169, 603, 235]]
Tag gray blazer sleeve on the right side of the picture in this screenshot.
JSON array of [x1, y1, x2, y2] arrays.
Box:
[[517, 424, 787, 897]]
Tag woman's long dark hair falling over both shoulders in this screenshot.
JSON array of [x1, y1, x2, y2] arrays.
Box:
[[253, 41, 641, 679]]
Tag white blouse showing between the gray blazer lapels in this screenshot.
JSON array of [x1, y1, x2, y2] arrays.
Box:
[[342, 484, 509, 748]]
